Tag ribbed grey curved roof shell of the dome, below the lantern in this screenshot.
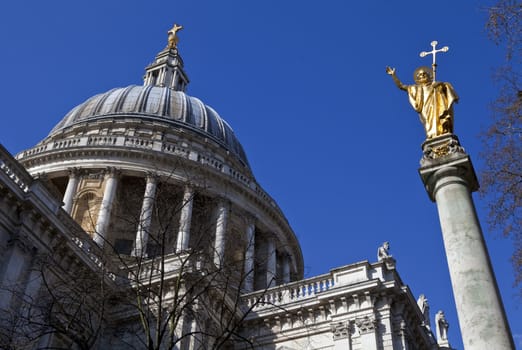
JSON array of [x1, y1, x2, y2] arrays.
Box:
[[49, 85, 250, 168]]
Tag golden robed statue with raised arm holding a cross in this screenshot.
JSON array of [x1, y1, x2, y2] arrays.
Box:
[[386, 41, 459, 139]]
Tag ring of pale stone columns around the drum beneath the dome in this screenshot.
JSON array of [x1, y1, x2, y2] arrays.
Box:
[[57, 168, 297, 291]]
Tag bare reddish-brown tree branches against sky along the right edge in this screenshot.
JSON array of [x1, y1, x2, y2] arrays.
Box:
[[481, 0, 522, 284]]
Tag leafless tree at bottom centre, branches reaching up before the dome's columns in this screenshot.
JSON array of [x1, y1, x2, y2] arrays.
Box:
[[104, 178, 278, 350]]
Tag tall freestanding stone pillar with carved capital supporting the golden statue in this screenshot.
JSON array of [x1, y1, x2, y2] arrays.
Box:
[[419, 135, 514, 350]]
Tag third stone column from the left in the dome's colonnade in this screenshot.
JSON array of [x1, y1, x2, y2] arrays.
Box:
[[132, 174, 158, 257]]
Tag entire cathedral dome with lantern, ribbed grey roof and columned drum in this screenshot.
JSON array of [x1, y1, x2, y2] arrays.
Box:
[[17, 41, 304, 291]]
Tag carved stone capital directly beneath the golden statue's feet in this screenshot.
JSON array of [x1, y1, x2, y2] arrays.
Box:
[[419, 134, 479, 202]]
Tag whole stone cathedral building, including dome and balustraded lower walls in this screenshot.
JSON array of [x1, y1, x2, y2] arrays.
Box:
[[0, 40, 439, 350]]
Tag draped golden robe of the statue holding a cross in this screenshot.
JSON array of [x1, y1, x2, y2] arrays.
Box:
[[408, 82, 459, 139]]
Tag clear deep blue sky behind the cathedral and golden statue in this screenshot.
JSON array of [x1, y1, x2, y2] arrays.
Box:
[[0, 0, 522, 349]]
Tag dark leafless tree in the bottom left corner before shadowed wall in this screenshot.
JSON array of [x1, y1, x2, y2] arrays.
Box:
[[0, 243, 110, 350]]
